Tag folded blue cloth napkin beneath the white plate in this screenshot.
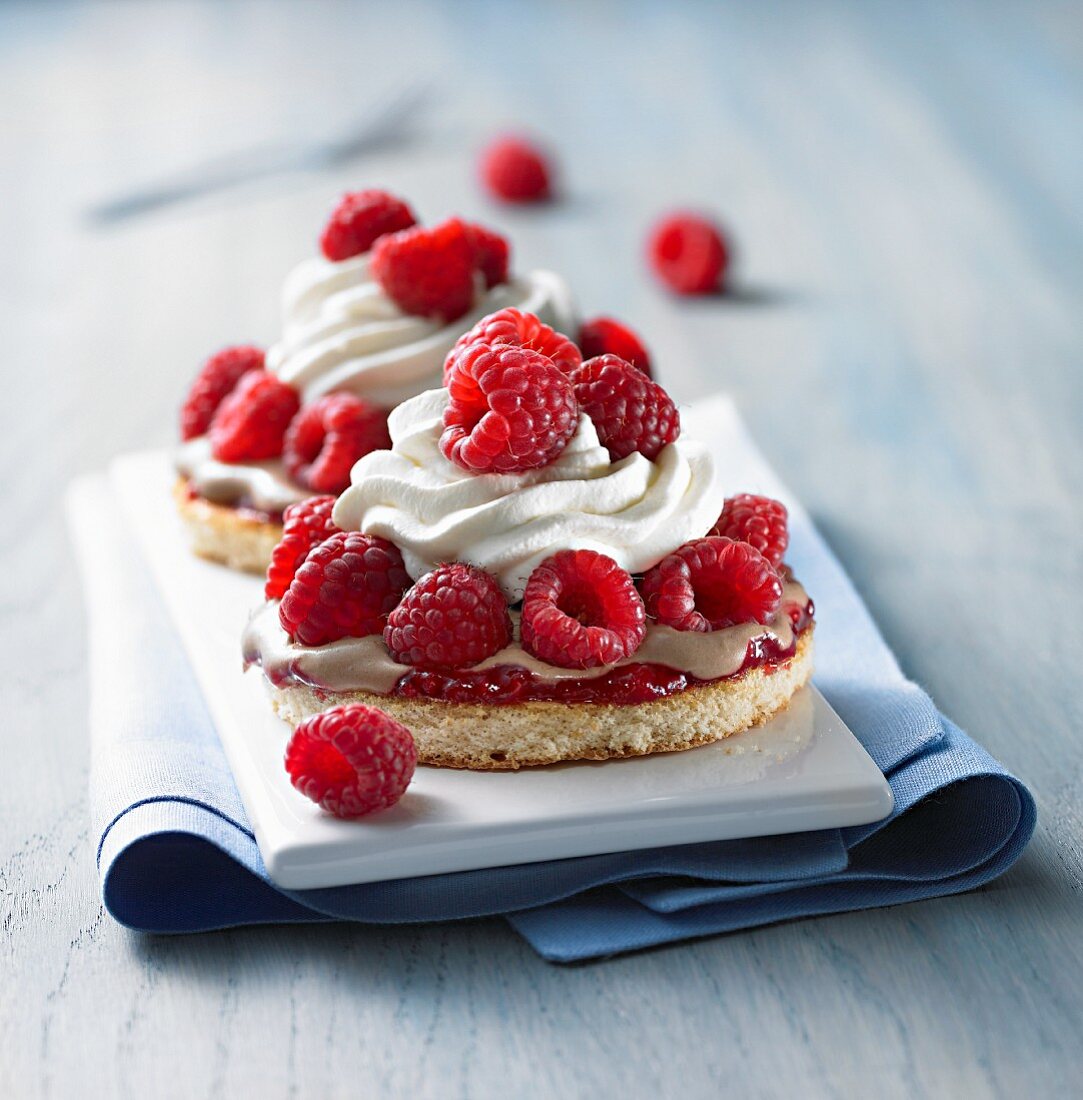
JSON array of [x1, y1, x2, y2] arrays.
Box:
[[69, 409, 1036, 961]]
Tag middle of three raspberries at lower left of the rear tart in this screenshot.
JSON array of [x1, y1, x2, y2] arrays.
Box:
[[210, 371, 301, 462]]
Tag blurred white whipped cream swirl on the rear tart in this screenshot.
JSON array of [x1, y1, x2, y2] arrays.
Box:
[[267, 253, 576, 408]]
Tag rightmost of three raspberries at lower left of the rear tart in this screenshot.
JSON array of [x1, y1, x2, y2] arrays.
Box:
[[283, 394, 391, 495]]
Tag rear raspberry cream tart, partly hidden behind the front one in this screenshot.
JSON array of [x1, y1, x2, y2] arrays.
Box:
[[174, 191, 578, 572]]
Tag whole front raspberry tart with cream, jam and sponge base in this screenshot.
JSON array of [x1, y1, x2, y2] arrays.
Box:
[[243, 319, 814, 770]]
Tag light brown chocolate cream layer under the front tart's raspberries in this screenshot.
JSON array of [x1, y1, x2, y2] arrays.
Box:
[[242, 580, 808, 695]]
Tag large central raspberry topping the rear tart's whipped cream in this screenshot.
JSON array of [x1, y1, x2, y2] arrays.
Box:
[[372, 218, 474, 321]]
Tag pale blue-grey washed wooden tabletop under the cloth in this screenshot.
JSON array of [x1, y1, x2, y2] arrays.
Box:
[[0, 0, 1083, 1098]]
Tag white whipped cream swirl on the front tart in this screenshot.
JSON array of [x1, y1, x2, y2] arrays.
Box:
[[334, 389, 721, 603]]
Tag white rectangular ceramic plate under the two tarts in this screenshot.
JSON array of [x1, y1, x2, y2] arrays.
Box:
[[111, 452, 893, 889]]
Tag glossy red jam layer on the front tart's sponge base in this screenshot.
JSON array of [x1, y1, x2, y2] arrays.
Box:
[[391, 601, 814, 706]]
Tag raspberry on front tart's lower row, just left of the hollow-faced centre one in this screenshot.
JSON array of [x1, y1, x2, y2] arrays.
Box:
[[384, 562, 511, 669]]
